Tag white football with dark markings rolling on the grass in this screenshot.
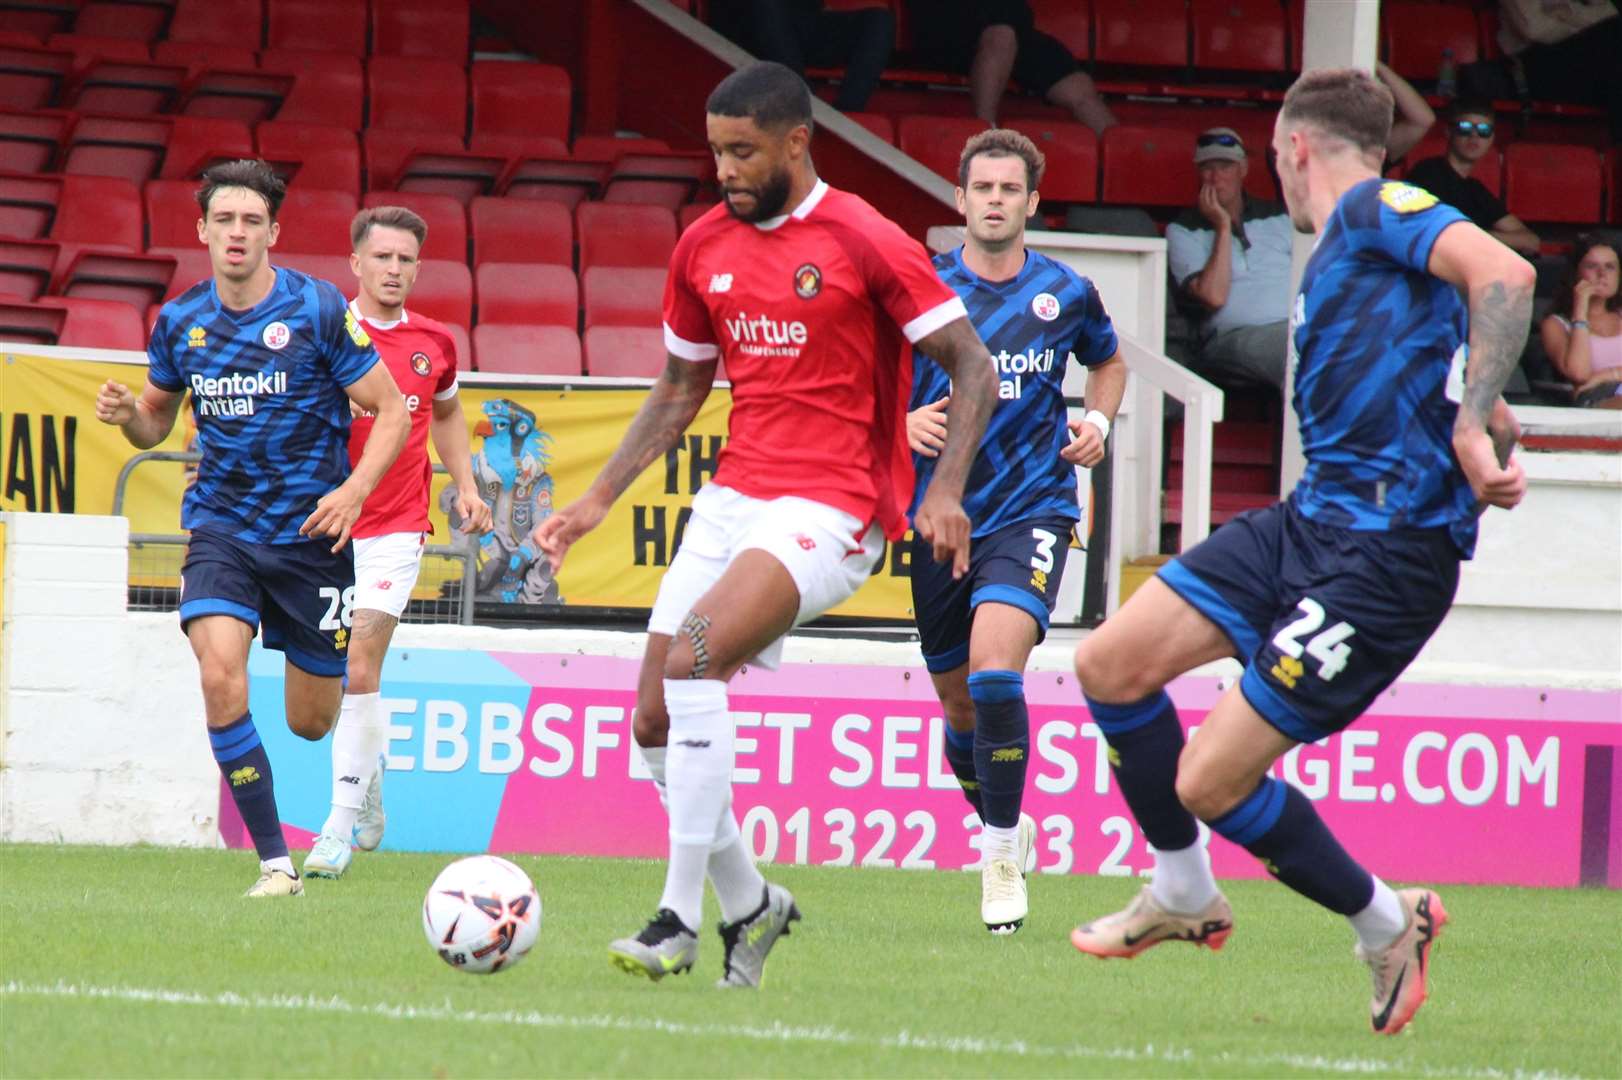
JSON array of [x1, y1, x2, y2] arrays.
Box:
[[422, 855, 540, 975]]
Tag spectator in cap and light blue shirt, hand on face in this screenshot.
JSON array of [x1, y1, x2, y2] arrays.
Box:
[[1166, 128, 1294, 389]]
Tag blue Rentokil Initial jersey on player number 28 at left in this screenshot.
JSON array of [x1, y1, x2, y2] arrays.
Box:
[[146, 266, 378, 543]]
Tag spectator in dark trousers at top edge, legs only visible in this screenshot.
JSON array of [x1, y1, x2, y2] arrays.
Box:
[[710, 0, 895, 112]]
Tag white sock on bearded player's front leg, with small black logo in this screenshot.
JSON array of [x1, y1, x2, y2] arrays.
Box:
[[659, 679, 736, 931]]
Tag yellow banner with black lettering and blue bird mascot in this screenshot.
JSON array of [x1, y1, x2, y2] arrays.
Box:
[[0, 354, 912, 619]]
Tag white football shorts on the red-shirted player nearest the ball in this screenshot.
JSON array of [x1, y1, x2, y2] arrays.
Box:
[[647, 483, 884, 671]]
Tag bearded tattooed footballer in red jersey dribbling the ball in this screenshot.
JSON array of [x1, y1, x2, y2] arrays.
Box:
[[535, 63, 996, 986]]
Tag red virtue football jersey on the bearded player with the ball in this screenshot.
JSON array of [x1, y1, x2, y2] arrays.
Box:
[[665, 180, 967, 540]]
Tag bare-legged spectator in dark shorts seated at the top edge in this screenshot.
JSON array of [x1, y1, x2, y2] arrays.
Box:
[[907, 0, 1116, 135]]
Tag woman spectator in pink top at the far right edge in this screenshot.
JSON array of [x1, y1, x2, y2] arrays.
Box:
[[1541, 234, 1622, 409]]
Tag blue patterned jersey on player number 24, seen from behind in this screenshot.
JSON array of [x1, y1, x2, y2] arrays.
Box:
[[1289, 178, 1476, 558]]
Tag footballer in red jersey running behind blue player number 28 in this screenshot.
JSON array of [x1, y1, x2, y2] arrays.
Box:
[[303, 206, 490, 877]]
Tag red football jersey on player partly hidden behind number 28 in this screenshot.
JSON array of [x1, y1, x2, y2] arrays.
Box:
[[349, 303, 456, 540]]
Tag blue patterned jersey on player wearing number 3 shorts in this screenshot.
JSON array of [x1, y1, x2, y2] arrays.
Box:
[[908, 241, 1118, 537]]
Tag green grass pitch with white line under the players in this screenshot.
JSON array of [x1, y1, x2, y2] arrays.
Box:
[[0, 845, 1622, 1078]]
